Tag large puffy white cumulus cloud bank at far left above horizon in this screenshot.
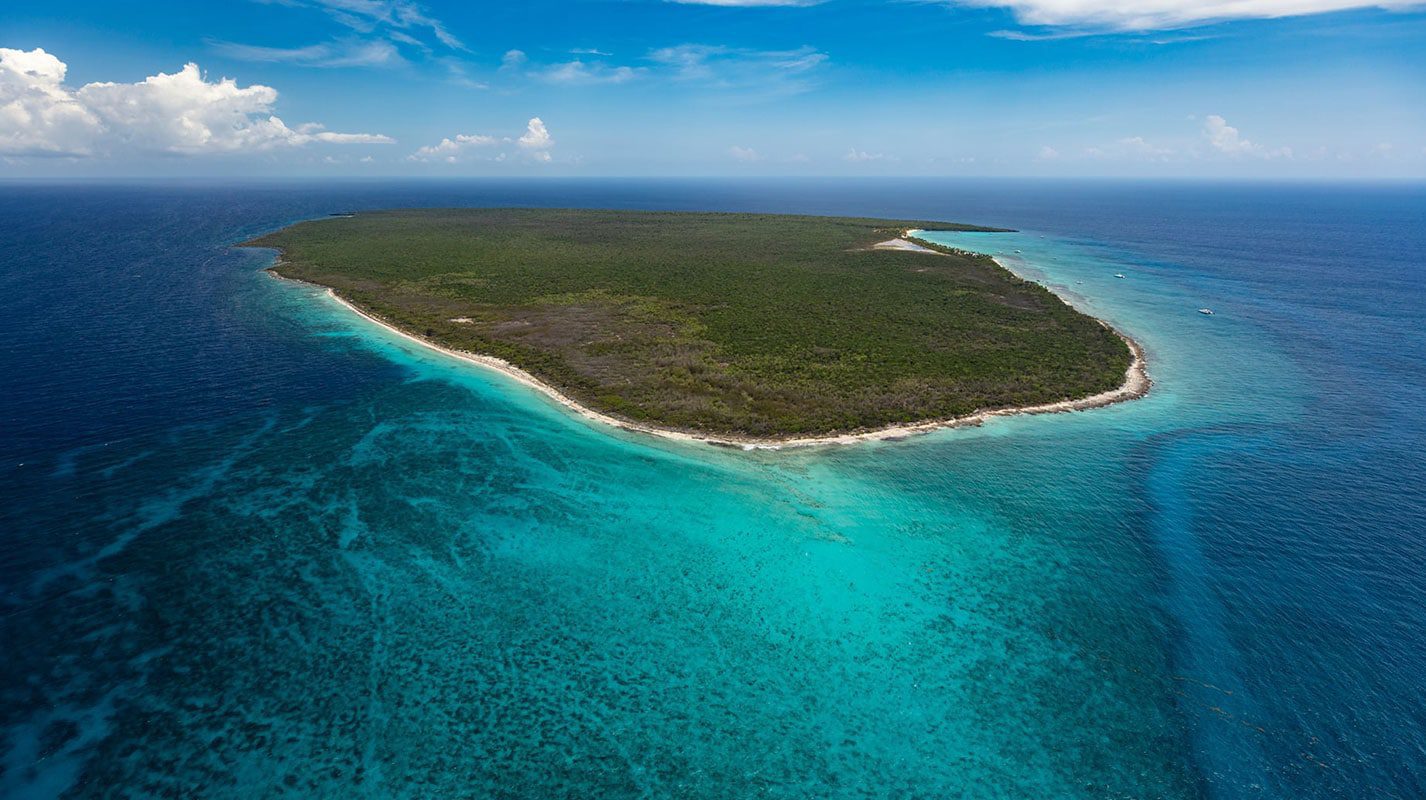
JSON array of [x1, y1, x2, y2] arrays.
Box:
[[0, 47, 394, 157]]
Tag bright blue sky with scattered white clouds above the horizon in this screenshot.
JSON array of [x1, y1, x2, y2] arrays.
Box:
[[0, 0, 1426, 178]]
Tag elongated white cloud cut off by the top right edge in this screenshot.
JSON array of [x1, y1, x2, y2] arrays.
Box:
[[951, 0, 1420, 30]]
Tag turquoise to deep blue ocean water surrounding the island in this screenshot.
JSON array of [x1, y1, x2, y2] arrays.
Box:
[[0, 180, 1426, 799]]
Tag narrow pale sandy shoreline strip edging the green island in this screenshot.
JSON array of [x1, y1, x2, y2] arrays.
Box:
[[265, 249, 1154, 451]]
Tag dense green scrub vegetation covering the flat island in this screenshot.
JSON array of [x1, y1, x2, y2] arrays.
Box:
[[247, 208, 1131, 436]]
